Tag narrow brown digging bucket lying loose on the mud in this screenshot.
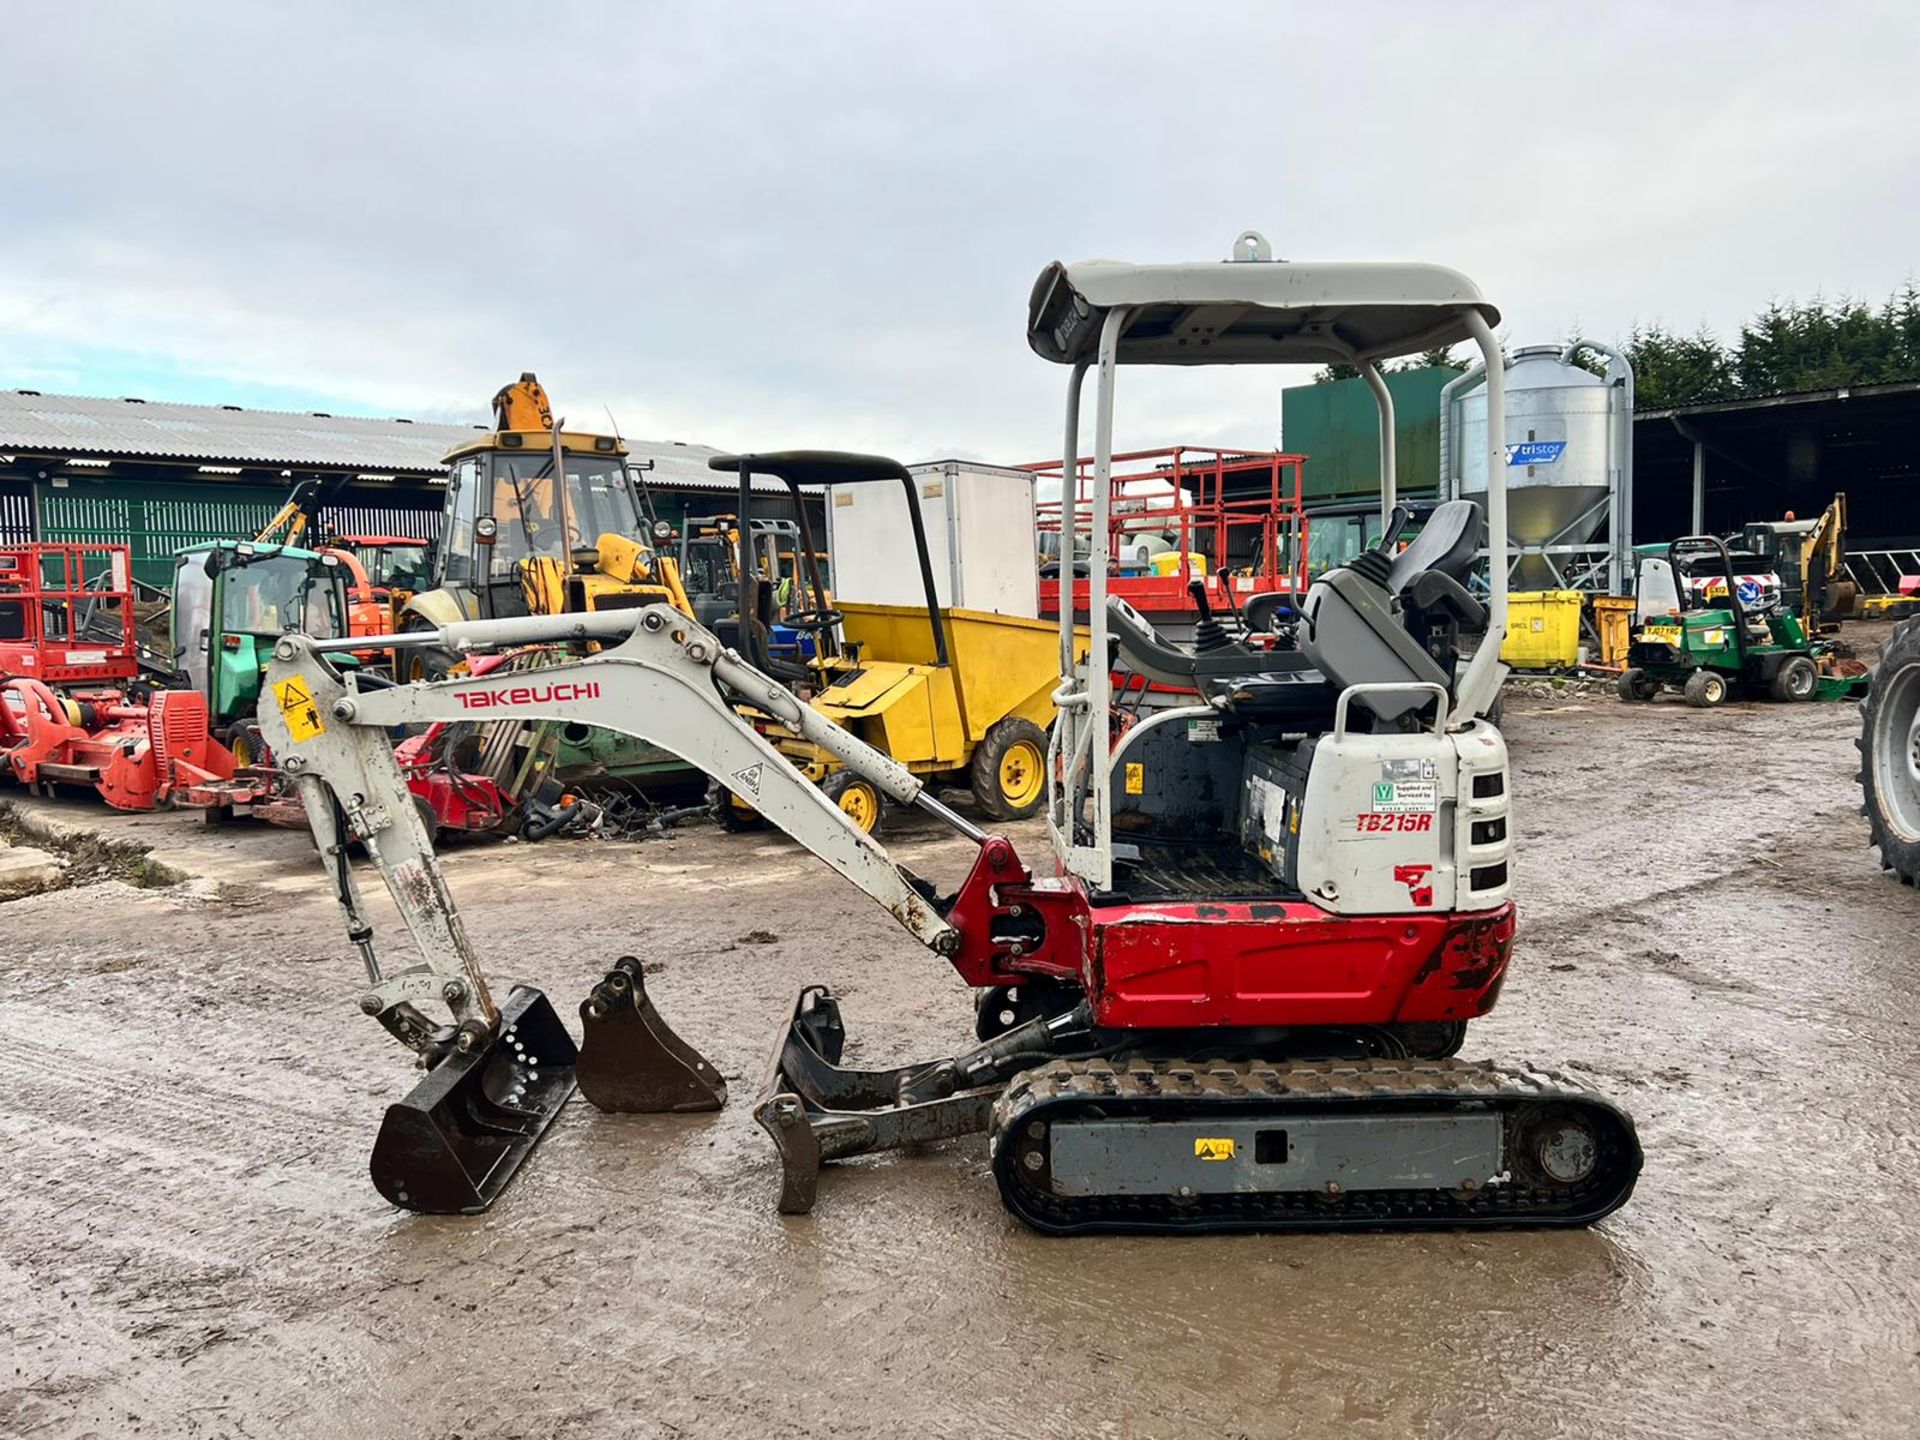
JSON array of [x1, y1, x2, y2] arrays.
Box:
[[578, 954, 726, 1114]]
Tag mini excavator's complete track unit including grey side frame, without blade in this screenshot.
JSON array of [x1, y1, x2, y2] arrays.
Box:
[[993, 1060, 1642, 1235]]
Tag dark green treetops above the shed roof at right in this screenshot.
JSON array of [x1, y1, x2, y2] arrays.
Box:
[[1313, 280, 1920, 411]]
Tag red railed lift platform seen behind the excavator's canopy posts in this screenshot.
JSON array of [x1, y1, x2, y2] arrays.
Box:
[[1020, 445, 1306, 639]]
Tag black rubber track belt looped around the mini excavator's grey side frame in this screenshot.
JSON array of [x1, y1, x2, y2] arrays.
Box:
[[993, 1060, 1642, 1235]]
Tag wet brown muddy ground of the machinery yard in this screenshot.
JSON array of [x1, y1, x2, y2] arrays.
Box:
[[0, 679, 1920, 1440]]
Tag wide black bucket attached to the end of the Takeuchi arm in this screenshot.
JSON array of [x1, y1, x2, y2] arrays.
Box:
[[371, 985, 578, 1215]]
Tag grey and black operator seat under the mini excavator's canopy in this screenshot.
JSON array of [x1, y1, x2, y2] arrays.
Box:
[[1300, 499, 1480, 724]]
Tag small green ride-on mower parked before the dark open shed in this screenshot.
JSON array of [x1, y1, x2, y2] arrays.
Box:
[[1619, 536, 1866, 708]]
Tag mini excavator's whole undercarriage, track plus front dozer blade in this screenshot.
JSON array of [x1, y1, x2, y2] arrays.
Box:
[[755, 987, 1642, 1235]]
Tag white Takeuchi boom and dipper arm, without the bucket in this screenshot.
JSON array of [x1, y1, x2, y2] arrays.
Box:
[[261, 605, 960, 1054]]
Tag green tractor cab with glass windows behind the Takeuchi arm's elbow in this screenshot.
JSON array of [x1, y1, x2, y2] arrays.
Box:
[[169, 540, 349, 730]]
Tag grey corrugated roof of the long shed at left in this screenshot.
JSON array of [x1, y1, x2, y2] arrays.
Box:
[[0, 390, 783, 493]]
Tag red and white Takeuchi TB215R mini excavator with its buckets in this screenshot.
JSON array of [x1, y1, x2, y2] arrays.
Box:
[[251, 232, 1640, 1233]]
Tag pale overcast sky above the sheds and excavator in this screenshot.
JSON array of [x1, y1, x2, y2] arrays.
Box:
[[0, 0, 1920, 461]]
